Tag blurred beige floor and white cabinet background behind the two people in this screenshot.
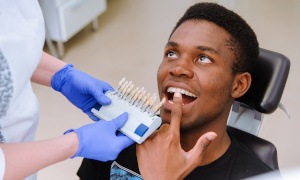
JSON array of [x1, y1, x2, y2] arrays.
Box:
[[33, 0, 300, 180]]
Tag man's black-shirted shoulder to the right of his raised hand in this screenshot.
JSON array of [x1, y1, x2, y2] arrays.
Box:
[[186, 134, 272, 180]]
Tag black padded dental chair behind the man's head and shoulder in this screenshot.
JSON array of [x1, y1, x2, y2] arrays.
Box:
[[227, 48, 290, 170]]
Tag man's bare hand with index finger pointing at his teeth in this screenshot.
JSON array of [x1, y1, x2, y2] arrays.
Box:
[[137, 93, 217, 180]]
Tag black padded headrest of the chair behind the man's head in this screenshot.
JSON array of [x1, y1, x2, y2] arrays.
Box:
[[236, 48, 290, 114]]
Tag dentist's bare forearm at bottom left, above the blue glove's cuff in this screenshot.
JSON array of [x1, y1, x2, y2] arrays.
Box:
[[0, 133, 78, 179]]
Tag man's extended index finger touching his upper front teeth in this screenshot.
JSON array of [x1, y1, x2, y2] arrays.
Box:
[[170, 92, 182, 135]]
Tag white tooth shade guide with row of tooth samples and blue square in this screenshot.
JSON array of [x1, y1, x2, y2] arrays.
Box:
[[92, 78, 163, 144]]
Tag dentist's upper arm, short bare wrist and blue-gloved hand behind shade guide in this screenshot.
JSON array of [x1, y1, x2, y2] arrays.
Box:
[[31, 52, 113, 121]]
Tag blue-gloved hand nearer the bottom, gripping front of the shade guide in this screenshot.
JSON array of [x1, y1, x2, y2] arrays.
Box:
[[64, 113, 134, 161]]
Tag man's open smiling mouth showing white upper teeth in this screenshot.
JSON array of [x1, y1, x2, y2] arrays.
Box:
[[166, 87, 197, 105]]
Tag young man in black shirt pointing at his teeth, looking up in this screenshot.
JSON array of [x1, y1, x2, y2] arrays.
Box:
[[78, 3, 272, 180]]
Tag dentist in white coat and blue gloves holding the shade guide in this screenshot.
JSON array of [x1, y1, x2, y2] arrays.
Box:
[[0, 0, 133, 179]]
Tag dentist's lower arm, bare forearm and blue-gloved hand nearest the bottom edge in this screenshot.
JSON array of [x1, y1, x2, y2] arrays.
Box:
[[0, 113, 133, 179]]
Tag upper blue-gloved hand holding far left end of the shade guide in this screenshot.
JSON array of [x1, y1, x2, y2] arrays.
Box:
[[51, 64, 113, 121]]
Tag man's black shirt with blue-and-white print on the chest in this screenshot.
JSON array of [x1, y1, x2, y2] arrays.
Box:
[[77, 130, 272, 180]]
